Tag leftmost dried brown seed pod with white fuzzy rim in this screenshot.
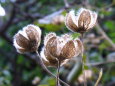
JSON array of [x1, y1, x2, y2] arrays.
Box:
[[14, 24, 41, 53]]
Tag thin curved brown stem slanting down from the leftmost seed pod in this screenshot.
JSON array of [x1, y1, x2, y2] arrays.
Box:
[[36, 51, 70, 86]]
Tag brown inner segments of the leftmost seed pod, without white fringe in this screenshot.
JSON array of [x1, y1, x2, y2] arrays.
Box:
[[15, 26, 40, 53]]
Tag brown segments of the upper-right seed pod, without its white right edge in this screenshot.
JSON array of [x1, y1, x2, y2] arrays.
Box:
[[65, 10, 91, 33]]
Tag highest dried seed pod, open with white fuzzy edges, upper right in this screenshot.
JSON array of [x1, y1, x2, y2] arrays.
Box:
[[65, 8, 97, 33]]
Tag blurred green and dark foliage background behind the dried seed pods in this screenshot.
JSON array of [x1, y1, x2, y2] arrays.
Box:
[[0, 0, 115, 86]]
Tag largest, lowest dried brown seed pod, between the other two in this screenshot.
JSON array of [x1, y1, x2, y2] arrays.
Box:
[[41, 33, 83, 66]]
